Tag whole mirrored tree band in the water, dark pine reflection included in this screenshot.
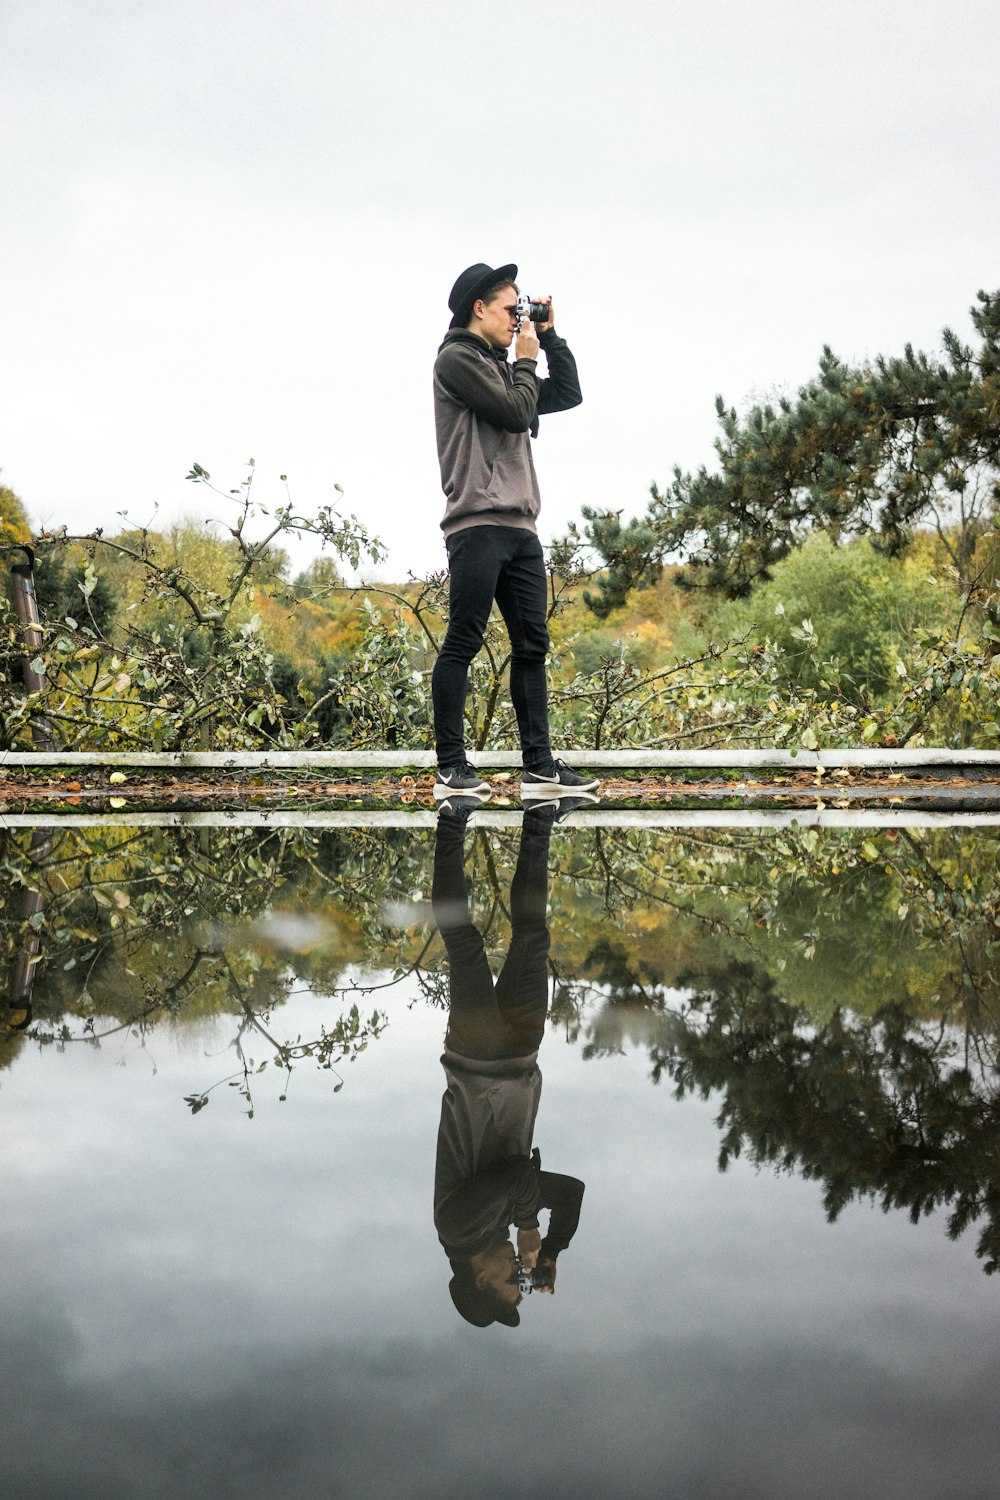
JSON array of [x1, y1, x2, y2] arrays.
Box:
[[0, 827, 1000, 1271]]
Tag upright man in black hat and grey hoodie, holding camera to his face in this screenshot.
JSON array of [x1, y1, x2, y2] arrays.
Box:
[[432, 264, 600, 800]]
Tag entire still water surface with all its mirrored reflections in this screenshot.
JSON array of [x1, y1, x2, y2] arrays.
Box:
[[0, 815, 1000, 1500]]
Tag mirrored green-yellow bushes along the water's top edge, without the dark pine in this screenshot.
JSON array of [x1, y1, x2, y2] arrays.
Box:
[[0, 827, 1000, 1035]]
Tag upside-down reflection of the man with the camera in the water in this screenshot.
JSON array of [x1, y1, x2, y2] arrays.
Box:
[[433, 807, 583, 1328]]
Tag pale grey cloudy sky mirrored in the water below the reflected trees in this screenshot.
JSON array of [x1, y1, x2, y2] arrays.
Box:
[[0, 986, 1000, 1500]]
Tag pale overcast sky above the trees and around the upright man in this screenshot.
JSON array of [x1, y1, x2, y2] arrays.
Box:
[[0, 0, 1000, 576]]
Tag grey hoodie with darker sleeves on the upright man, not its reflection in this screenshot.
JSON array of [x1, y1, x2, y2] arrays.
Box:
[[433, 329, 583, 537]]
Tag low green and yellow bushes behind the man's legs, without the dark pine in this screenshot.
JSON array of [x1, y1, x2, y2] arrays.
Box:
[[0, 441, 1000, 750]]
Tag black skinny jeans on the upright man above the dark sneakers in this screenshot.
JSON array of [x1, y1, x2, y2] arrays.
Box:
[[430, 527, 552, 771]]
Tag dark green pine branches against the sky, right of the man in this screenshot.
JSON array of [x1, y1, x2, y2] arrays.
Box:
[[585, 291, 1000, 615]]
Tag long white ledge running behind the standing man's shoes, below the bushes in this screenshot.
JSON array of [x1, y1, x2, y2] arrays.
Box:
[[0, 750, 1000, 776]]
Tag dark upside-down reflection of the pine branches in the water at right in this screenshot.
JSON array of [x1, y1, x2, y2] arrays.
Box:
[[652, 962, 1000, 1272]]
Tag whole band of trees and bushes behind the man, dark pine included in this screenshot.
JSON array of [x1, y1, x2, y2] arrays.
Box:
[[0, 283, 1000, 750]]
